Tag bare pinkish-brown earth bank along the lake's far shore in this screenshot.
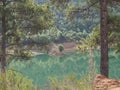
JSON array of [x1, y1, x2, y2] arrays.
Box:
[[7, 41, 77, 56]]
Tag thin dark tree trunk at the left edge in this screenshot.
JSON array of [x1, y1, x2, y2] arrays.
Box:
[[1, 1, 6, 74]]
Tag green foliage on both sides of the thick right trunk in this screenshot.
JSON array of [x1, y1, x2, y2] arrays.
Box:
[[81, 15, 120, 52]]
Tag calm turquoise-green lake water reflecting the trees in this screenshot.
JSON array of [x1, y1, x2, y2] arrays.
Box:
[[9, 51, 120, 86]]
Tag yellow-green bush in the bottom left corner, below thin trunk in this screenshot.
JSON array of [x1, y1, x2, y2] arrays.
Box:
[[0, 69, 34, 90]]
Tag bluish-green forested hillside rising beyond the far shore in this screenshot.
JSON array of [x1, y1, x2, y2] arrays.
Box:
[[33, 0, 99, 41]]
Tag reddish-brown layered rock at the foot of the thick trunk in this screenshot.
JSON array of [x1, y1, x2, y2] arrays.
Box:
[[93, 74, 120, 90]]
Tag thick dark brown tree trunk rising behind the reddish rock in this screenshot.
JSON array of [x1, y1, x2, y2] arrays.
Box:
[[100, 0, 109, 77]]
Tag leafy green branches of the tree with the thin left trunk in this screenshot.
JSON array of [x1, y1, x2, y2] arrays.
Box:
[[0, 0, 54, 58]]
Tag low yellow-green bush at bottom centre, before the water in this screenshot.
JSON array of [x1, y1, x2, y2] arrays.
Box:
[[50, 74, 92, 90]]
